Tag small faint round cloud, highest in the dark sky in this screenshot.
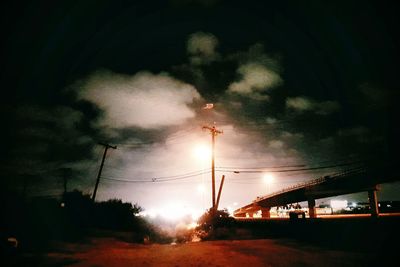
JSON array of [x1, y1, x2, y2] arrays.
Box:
[[187, 32, 219, 65]]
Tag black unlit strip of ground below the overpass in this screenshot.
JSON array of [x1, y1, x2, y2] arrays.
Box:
[[236, 216, 400, 253]]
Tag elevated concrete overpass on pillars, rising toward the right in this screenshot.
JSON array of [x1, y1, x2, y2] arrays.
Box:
[[234, 163, 400, 218]]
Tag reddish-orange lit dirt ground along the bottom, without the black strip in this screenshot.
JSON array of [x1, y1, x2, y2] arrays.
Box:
[[17, 238, 396, 267]]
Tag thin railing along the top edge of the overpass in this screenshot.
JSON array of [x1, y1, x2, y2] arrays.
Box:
[[253, 167, 366, 202]]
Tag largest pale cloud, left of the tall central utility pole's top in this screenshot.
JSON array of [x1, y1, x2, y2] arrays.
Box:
[[78, 71, 200, 129]]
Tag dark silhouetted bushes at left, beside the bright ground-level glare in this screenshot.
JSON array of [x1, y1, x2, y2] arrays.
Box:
[[0, 191, 173, 252]]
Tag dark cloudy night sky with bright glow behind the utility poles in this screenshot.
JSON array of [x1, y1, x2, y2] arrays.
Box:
[[0, 0, 400, 218]]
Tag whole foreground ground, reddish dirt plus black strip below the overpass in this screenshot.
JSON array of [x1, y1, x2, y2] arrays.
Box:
[[2, 217, 400, 267]]
